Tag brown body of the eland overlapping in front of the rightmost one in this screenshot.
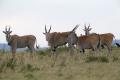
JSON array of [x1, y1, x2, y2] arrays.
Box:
[[76, 34, 100, 53]]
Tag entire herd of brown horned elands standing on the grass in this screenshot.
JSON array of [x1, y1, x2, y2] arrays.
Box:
[[3, 25, 114, 59]]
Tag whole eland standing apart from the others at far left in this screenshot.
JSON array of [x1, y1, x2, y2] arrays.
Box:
[[3, 26, 36, 59]]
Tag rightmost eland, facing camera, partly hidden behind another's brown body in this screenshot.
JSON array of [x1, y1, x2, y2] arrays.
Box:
[[83, 24, 114, 53]]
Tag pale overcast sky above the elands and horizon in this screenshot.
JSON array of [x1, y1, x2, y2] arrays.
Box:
[[0, 0, 120, 47]]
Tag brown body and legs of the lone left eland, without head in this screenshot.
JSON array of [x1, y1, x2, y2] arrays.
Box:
[[8, 35, 36, 58]]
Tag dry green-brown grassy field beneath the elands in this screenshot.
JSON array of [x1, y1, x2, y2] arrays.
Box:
[[0, 47, 120, 80]]
